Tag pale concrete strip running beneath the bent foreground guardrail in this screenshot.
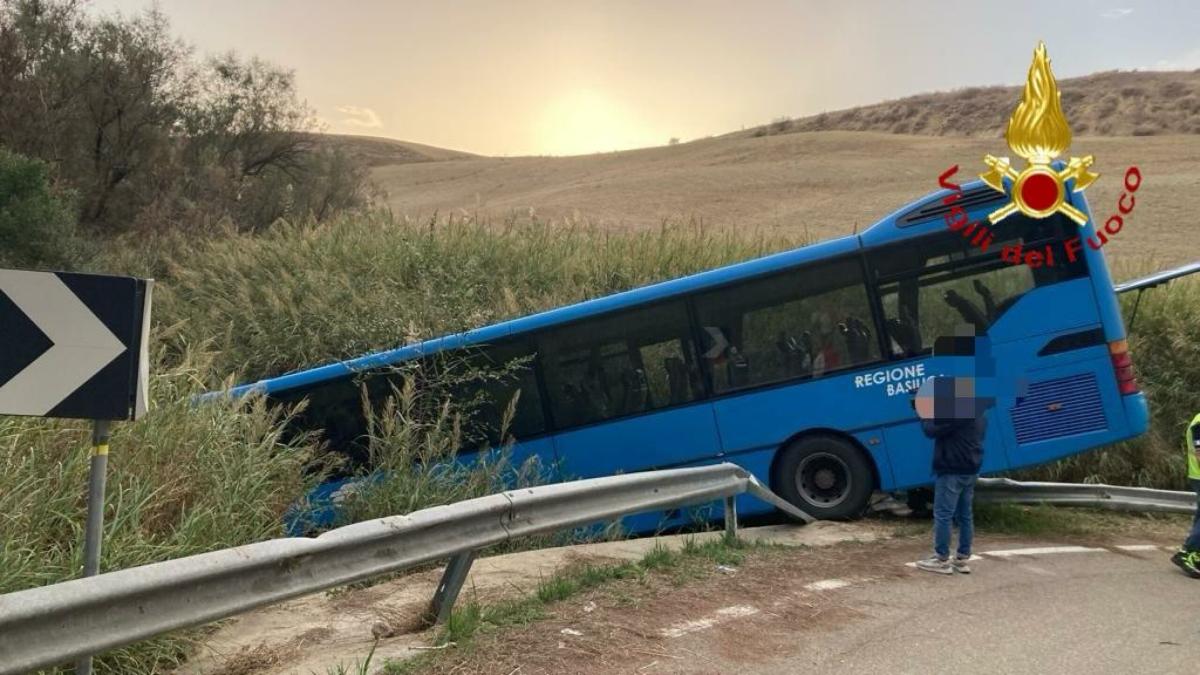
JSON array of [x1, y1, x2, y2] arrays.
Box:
[[176, 521, 894, 675]]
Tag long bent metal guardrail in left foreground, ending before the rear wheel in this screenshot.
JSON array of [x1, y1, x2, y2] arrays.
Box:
[[0, 464, 814, 675]]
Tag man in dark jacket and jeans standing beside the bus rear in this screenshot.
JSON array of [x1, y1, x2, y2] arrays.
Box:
[[914, 377, 988, 574]]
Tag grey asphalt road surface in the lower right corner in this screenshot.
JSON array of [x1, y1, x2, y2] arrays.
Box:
[[745, 544, 1200, 675]]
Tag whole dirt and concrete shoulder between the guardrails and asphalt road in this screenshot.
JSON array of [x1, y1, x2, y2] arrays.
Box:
[[171, 507, 1186, 675]]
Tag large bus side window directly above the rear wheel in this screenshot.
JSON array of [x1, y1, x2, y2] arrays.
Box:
[[696, 254, 880, 393]]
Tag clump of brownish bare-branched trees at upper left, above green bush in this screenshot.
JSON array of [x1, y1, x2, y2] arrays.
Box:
[[0, 0, 370, 232]]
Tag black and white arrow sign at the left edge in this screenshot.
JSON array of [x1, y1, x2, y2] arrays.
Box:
[[0, 269, 152, 420]]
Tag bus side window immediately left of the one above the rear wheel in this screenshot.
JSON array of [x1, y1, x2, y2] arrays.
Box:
[[539, 301, 701, 429]]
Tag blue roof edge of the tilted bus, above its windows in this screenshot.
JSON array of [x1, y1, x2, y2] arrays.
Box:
[[203, 180, 1006, 399]]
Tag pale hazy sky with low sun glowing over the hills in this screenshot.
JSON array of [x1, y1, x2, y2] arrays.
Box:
[[91, 0, 1200, 156]]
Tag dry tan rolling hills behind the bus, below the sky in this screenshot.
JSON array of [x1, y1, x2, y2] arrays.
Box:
[[340, 72, 1200, 264]]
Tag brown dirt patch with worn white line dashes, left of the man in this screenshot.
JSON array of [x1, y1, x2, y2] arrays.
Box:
[[397, 533, 920, 675]]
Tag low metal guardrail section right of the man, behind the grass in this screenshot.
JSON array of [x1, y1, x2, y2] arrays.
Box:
[[976, 478, 1196, 513]]
